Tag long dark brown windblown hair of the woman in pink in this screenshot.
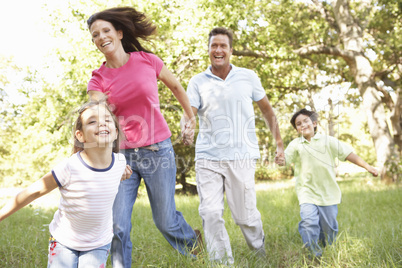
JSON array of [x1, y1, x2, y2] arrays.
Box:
[[87, 7, 156, 53]]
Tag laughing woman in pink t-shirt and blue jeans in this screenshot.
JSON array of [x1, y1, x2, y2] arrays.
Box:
[[88, 7, 203, 267]]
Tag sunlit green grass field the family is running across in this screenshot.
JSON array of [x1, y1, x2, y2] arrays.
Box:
[[0, 177, 402, 268]]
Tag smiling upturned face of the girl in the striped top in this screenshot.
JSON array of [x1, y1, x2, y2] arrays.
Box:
[[75, 105, 118, 149]]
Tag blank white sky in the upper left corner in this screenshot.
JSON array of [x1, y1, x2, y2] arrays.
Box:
[[0, 0, 58, 104]]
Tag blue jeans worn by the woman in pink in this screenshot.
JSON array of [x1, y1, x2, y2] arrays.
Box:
[[111, 138, 196, 268]]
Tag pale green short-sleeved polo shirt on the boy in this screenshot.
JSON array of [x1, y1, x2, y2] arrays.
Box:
[[285, 133, 353, 206]]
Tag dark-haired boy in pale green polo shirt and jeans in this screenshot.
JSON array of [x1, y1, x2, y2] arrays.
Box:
[[275, 109, 378, 258]]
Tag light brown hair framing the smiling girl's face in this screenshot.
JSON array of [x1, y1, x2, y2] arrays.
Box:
[[72, 99, 123, 154]]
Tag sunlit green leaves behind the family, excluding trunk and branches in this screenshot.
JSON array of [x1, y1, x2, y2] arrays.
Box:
[[0, 0, 402, 184]]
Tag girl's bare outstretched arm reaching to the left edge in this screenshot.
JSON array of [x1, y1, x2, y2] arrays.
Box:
[[0, 172, 58, 222]]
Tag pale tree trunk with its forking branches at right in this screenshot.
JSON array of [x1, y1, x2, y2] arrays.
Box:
[[296, 0, 402, 180]]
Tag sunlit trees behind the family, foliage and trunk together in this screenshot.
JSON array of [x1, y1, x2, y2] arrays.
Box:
[[0, 0, 402, 188]]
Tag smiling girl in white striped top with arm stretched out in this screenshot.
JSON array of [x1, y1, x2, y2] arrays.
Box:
[[0, 102, 131, 268]]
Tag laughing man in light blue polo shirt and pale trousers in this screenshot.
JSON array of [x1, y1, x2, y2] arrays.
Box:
[[187, 27, 284, 264]]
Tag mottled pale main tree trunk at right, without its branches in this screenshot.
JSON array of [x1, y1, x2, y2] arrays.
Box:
[[332, 0, 395, 179]]
